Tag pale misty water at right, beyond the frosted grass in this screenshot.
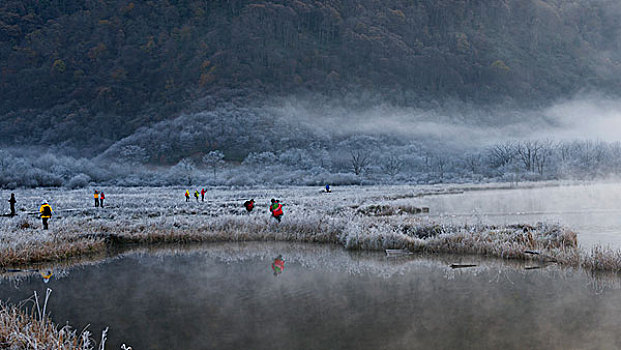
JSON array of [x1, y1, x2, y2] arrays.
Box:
[[416, 183, 621, 249]]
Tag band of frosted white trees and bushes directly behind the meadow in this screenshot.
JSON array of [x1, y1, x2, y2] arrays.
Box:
[[0, 136, 621, 188]]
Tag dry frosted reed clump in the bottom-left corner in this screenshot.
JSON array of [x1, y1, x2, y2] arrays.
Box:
[[0, 289, 107, 350]]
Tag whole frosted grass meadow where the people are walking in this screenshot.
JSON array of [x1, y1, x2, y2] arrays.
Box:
[[0, 184, 596, 269]]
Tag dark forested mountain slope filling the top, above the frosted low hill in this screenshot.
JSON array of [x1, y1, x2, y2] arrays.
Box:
[[0, 0, 621, 151]]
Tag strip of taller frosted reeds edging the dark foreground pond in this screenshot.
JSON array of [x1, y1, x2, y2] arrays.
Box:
[[0, 217, 588, 271]]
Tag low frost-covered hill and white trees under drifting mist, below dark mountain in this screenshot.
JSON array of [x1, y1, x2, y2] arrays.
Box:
[[6, 95, 621, 188]]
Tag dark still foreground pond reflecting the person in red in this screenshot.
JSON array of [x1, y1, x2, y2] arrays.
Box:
[[0, 243, 621, 350]]
